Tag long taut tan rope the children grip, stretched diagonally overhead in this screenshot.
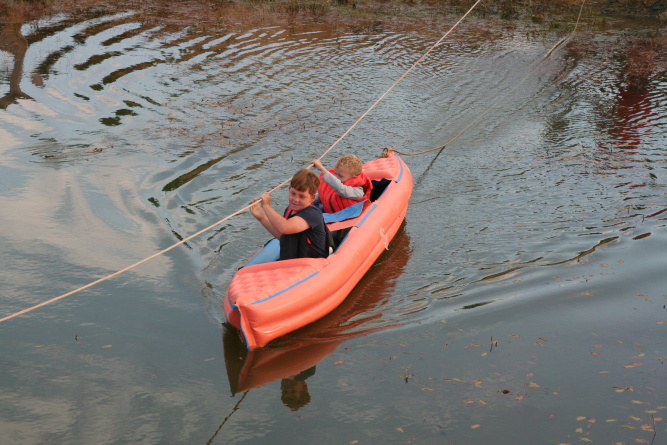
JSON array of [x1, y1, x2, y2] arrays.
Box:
[[0, 0, 482, 323]]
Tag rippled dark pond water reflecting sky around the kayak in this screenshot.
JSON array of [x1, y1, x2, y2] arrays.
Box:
[[0, 6, 667, 444]]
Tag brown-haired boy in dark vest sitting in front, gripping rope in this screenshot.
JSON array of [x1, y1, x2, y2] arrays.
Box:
[[250, 168, 329, 260]]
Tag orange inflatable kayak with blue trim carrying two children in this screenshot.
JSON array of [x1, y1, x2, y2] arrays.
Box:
[[224, 150, 412, 350]]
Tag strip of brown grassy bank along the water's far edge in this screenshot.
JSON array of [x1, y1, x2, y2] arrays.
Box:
[[0, 0, 667, 29]]
